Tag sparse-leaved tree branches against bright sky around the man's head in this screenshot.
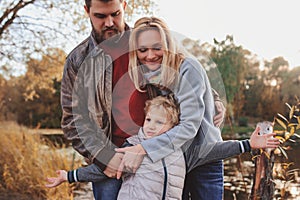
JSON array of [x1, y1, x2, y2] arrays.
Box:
[[0, 0, 155, 76]]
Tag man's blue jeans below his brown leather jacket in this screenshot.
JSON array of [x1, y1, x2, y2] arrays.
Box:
[[92, 178, 122, 200]]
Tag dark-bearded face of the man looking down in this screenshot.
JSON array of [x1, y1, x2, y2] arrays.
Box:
[[85, 0, 126, 43]]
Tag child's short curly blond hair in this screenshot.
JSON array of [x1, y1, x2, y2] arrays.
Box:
[[144, 95, 180, 126]]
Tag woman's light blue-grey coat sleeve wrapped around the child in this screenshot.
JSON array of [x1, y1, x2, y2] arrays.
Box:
[[141, 59, 222, 162]]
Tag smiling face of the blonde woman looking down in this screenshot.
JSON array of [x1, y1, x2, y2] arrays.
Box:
[[137, 30, 163, 71]]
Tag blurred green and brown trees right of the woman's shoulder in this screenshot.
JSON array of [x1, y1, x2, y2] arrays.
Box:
[[182, 36, 300, 125]]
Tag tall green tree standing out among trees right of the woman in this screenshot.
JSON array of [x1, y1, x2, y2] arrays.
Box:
[[211, 35, 251, 122]]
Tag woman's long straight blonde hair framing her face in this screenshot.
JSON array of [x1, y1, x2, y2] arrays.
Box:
[[128, 17, 185, 91]]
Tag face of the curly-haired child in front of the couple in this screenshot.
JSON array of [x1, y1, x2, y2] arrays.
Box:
[[143, 106, 173, 138]]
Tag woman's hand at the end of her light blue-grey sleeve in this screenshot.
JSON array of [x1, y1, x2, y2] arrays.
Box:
[[116, 144, 146, 179]]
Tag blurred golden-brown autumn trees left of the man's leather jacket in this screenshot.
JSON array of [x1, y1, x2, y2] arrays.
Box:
[[1, 49, 66, 128]]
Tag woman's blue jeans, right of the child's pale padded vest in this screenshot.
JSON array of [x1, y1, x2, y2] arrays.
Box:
[[182, 161, 224, 200]]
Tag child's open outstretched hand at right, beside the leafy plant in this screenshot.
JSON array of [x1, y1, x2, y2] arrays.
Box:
[[250, 126, 280, 149]]
